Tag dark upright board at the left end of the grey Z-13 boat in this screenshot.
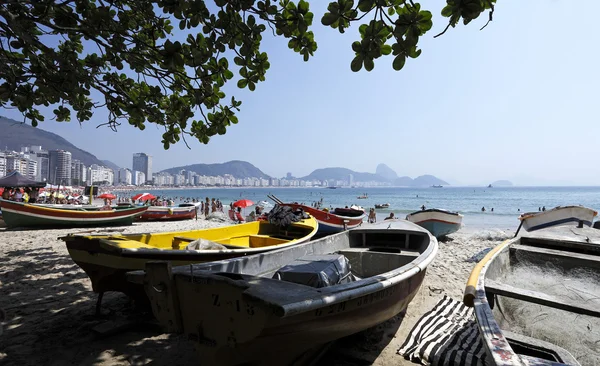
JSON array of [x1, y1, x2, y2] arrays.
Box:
[[144, 261, 183, 333]]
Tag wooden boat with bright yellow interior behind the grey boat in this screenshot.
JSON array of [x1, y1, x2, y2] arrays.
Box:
[[60, 217, 318, 306]]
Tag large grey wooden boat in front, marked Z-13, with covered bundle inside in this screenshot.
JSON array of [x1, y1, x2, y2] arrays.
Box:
[[128, 220, 438, 365]]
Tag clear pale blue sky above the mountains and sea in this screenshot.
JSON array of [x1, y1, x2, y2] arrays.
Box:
[[0, 0, 600, 185]]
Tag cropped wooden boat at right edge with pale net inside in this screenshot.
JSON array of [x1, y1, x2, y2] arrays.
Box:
[[464, 225, 600, 365]]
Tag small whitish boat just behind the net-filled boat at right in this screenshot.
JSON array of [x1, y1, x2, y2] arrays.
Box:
[[519, 206, 598, 231]]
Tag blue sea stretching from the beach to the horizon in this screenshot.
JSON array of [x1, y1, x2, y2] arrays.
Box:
[[115, 187, 600, 230]]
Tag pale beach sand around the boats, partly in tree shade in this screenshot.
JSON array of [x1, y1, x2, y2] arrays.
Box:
[[0, 220, 511, 365]]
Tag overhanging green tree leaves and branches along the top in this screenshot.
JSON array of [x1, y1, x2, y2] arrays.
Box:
[[0, 0, 495, 149]]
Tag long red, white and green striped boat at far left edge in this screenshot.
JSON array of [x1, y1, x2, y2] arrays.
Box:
[[0, 199, 147, 227]]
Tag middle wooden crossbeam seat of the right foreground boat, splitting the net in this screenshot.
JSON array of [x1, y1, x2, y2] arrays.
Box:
[[485, 279, 600, 317]]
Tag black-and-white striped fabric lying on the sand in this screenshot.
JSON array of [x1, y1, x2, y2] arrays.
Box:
[[398, 296, 491, 365]]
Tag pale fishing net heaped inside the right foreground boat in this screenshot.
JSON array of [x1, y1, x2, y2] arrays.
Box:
[[495, 252, 600, 365]]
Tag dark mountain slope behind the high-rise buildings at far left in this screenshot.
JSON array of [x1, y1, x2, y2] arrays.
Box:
[[0, 116, 105, 166]]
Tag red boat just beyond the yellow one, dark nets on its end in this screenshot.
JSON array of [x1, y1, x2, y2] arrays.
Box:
[[268, 195, 366, 235]]
